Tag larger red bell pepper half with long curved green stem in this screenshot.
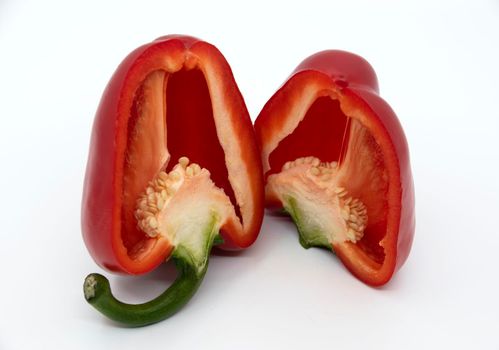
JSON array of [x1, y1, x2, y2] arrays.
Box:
[[82, 35, 264, 326]]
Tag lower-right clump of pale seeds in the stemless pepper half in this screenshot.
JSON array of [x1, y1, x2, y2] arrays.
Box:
[[334, 187, 367, 242]]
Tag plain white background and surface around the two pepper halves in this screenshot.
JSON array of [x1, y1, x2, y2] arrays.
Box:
[[0, 0, 499, 349]]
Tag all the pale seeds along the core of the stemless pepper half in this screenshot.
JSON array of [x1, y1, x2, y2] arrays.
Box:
[[282, 157, 367, 242]]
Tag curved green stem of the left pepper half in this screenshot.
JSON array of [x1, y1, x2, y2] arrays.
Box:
[[83, 257, 208, 327]]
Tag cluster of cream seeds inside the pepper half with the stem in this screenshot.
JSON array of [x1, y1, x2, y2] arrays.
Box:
[[135, 157, 201, 237]]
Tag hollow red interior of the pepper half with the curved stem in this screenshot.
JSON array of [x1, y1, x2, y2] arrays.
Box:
[[121, 68, 242, 254]]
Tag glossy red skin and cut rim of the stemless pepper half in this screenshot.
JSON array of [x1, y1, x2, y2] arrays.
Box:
[[255, 50, 415, 286]]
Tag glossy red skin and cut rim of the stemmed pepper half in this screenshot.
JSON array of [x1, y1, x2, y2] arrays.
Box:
[[81, 35, 263, 274]]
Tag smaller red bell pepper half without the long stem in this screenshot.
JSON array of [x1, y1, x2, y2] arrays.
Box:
[[255, 51, 415, 286]]
